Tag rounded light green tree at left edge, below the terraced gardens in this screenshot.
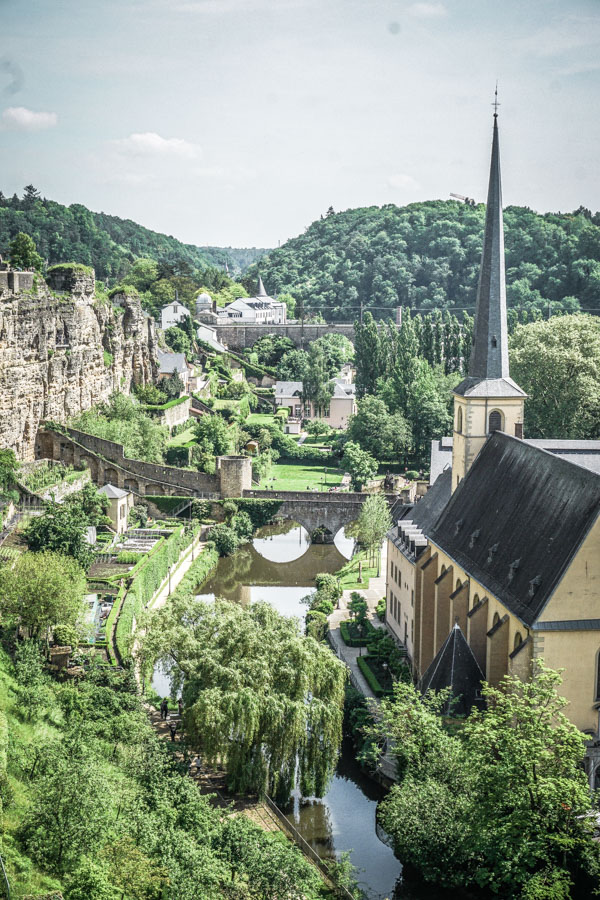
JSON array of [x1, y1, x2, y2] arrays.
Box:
[[0, 552, 86, 637]]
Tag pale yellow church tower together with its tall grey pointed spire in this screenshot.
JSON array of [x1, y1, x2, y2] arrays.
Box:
[[452, 104, 526, 490]]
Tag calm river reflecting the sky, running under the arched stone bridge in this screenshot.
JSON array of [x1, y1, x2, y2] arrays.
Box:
[[152, 522, 438, 900]]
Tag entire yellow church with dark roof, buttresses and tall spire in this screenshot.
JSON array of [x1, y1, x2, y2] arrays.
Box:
[[386, 110, 600, 789]]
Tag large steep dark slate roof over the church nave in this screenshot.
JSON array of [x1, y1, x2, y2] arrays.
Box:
[[428, 431, 600, 626]]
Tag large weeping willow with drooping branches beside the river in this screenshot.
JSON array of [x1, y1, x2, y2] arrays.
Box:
[[142, 597, 346, 799]]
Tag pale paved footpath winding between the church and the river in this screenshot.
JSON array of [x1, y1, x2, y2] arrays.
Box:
[[328, 541, 397, 781]]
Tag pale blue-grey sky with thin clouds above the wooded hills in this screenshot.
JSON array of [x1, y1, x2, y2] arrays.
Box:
[[0, 0, 600, 247]]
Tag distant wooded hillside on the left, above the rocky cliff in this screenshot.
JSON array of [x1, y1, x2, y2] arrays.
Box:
[[0, 185, 264, 281]]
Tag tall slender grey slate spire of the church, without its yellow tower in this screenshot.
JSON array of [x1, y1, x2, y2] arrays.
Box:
[[469, 104, 509, 379]]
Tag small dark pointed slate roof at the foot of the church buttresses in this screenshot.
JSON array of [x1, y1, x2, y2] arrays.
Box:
[[419, 625, 484, 716]]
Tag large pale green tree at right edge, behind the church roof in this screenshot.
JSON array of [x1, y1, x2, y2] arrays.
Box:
[[510, 315, 600, 439]]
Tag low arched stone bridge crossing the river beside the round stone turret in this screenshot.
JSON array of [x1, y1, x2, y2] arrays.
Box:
[[243, 490, 398, 542]]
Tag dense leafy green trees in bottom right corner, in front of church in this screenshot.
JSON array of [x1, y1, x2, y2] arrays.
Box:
[[372, 662, 600, 900]]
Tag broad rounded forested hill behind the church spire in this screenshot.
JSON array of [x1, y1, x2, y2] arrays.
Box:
[[249, 200, 600, 320]]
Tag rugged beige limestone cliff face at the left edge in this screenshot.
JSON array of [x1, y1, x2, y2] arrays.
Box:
[[0, 275, 157, 460]]
